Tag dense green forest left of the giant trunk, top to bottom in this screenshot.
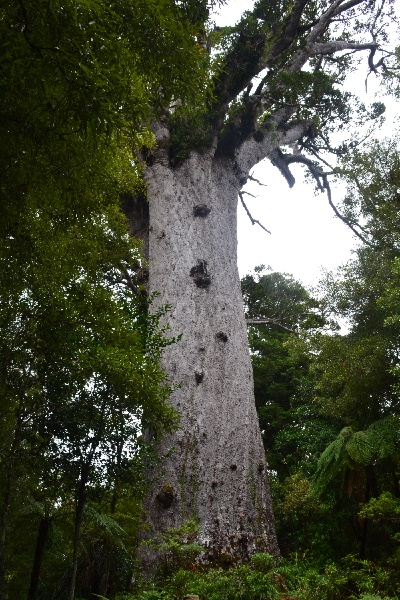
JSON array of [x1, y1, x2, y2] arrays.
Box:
[[0, 0, 204, 600]]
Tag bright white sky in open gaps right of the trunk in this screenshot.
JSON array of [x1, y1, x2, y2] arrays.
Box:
[[215, 0, 399, 286]]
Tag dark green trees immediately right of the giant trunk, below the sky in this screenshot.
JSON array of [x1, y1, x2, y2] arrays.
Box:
[[242, 266, 341, 564]]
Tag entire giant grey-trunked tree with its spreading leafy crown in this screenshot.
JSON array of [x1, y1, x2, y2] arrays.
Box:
[[138, 0, 392, 563]]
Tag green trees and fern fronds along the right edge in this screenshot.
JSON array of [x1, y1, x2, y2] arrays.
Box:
[[296, 135, 400, 564]]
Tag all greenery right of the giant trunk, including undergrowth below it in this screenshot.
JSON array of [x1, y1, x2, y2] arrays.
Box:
[[126, 139, 400, 600]]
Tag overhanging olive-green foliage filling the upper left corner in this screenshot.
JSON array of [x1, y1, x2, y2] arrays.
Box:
[[0, 0, 206, 241]]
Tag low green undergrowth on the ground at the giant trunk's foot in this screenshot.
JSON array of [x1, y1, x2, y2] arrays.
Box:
[[133, 555, 399, 600]]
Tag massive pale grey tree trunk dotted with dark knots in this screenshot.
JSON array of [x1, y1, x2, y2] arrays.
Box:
[[139, 123, 279, 562]]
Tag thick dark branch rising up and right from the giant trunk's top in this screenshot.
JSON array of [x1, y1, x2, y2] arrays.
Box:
[[217, 0, 384, 164]]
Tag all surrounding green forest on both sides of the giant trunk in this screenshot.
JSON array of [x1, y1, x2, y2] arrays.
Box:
[[0, 0, 400, 600]]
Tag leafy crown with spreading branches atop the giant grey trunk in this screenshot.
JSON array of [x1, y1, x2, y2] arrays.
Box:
[[170, 0, 396, 180]]
